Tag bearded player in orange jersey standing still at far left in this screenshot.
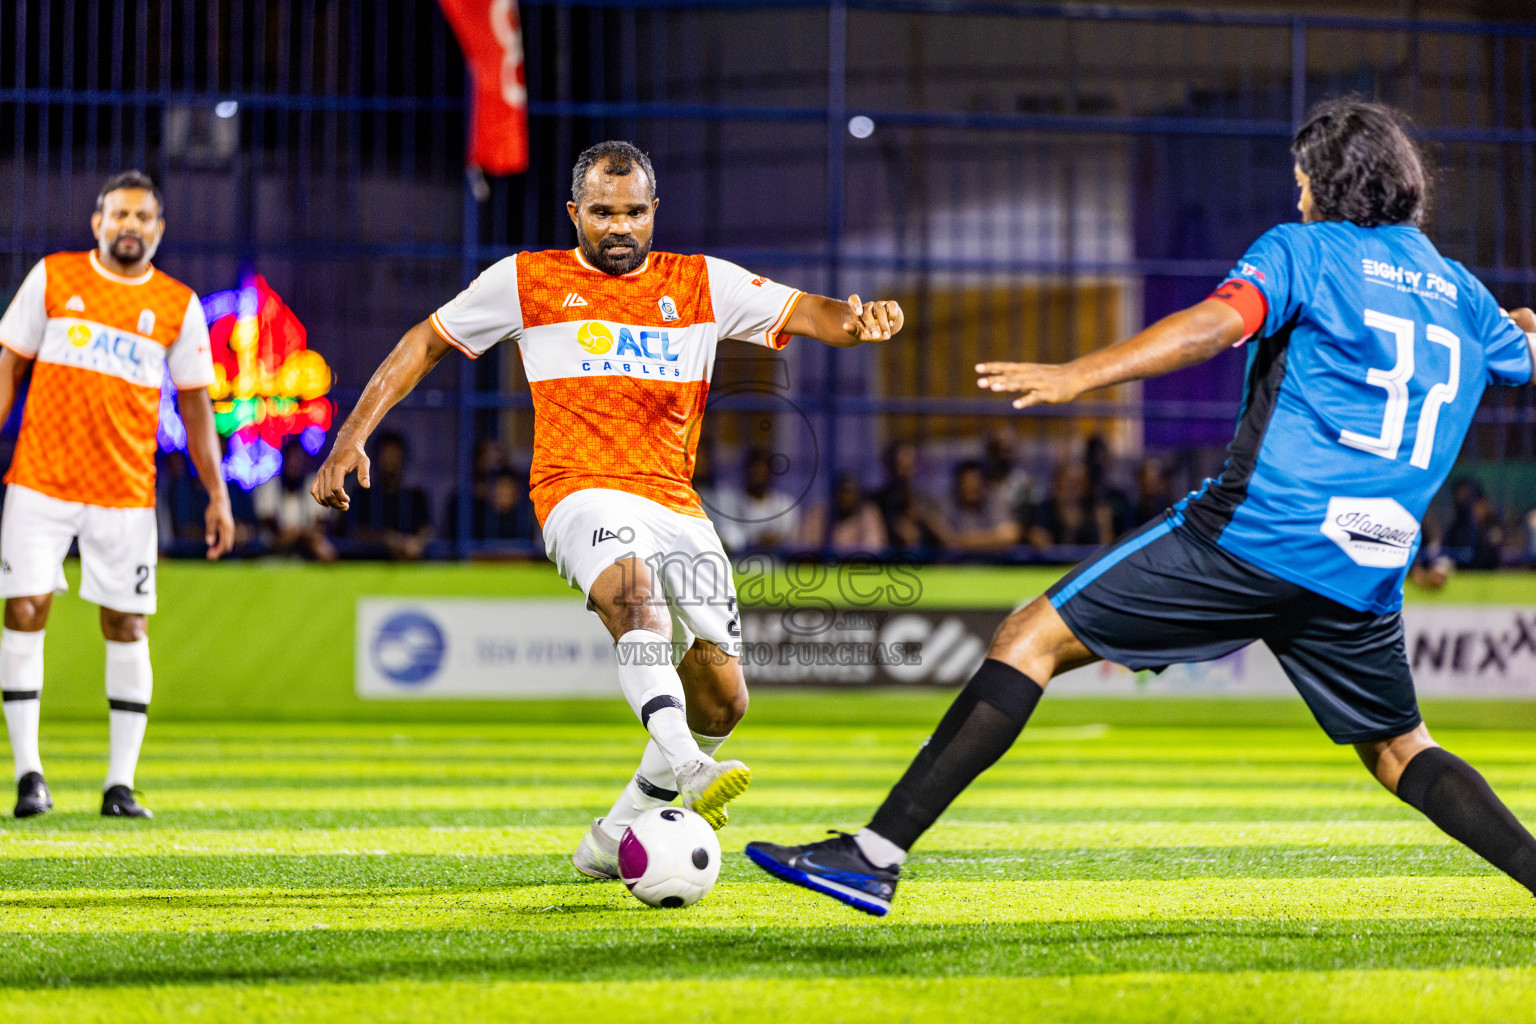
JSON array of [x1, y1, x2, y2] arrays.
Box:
[[0, 170, 235, 818]]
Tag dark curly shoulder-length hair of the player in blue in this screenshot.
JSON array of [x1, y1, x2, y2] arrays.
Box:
[[1290, 97, 1430, 227]]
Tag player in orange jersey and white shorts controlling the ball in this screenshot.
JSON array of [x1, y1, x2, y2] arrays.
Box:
[[312, 143, 902, 878]]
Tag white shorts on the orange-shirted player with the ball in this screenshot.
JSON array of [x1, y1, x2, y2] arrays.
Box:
[[544, 488, 742, 657]]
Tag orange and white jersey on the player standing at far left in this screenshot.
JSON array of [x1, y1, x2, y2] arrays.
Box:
[[0, 252, 214, 508]]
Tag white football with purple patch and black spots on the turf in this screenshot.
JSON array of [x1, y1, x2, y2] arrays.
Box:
[[619, 808, 720, 909]]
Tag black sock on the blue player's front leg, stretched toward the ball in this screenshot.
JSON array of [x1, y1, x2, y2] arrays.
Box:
[[869, 659, 1044, 849]]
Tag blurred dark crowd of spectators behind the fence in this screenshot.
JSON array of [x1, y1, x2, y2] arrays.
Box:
[[122, 428, 1536, 568]]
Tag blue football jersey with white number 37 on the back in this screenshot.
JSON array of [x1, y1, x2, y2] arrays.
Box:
[[1177, 223, 1533, 614]]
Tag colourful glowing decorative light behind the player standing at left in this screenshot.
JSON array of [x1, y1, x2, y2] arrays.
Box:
[[160, 273, 335, 491]]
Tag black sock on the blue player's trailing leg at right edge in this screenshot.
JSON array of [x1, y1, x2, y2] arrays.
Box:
[[1398, 746, 1536, 894]]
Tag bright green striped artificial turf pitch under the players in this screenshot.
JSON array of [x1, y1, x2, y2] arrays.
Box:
[[0, 709, 1536, 1024]]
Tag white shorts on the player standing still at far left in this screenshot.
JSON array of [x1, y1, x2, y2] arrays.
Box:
[[0, 484, 160, 616]]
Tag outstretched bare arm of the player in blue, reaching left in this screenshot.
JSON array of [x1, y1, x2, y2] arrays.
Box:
[[975, 299, 1247, 408]]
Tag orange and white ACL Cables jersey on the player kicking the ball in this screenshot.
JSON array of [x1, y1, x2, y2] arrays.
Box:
[[432, 249, 803, 524]]
